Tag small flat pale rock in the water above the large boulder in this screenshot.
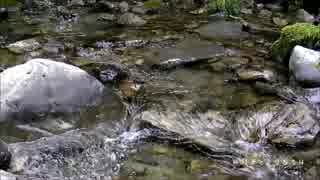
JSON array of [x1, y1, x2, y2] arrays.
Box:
[[7, 39, 41, 54]]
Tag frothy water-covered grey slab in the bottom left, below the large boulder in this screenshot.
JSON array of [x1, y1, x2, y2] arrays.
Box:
[[9, 129, 112, 180]]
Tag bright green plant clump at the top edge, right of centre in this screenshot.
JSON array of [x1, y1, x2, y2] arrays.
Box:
[[208, 0, 240, 15]]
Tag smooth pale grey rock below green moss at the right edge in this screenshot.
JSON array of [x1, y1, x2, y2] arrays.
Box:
[[289, 46, 320, 86]]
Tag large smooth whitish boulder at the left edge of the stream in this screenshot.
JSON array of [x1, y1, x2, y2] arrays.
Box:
[[0, 59, 104, 122]]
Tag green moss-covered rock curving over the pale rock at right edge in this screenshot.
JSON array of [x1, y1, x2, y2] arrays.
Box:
[[271, 23, 320, 62]]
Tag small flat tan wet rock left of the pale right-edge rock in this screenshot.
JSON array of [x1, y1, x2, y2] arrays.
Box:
[[237, 69, 275, 82]]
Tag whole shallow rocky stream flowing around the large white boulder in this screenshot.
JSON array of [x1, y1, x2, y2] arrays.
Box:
[[0, 0, 320, 180]]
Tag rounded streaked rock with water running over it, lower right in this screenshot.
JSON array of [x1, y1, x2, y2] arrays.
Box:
[[237, 103, 320, 146]]
